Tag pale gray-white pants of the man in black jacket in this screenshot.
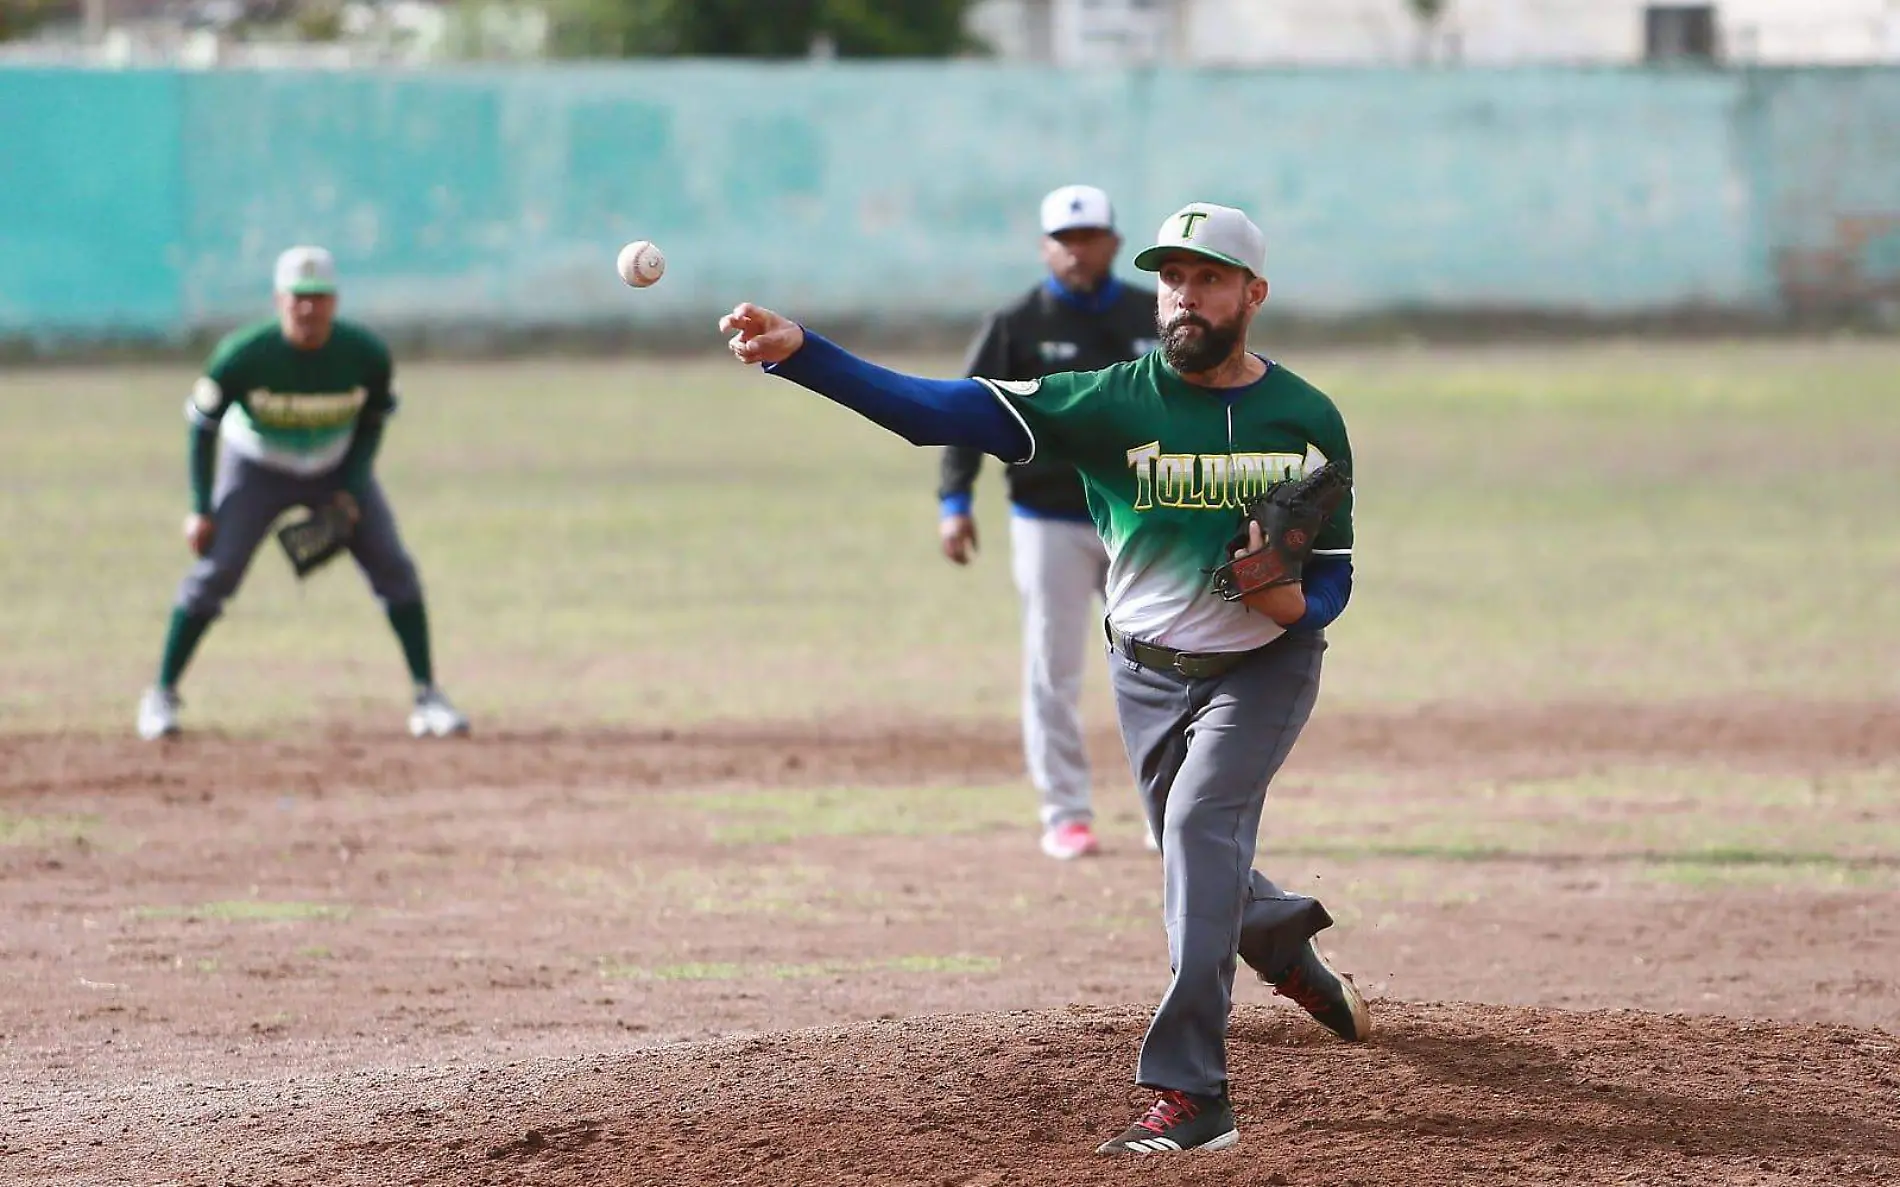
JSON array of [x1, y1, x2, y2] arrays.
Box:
[[1009, 515, 1108, 828]]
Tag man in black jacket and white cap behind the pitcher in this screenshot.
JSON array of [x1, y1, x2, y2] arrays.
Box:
[[939, 186, 1157, 860]]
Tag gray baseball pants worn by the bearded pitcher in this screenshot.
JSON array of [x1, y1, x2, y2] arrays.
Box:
[[1110, 634, 1332, 1094]]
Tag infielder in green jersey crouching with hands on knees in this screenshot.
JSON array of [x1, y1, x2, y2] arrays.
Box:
[[139, 247, 469, 739]]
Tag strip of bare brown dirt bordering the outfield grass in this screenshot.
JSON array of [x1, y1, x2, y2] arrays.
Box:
[[0, 701, 1900, 798]]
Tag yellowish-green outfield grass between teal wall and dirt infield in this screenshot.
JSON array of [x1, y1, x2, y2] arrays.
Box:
[[0, 342, 1900, 731]]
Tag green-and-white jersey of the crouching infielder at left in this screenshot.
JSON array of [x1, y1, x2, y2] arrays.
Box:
[[186, 321, 395, 475]]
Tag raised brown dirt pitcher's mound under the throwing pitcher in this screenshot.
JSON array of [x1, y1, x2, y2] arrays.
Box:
[[33, 1003, 1900, 1187]]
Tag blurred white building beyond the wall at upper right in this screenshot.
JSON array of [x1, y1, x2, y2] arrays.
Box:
[[971, 0, 1900, 66]]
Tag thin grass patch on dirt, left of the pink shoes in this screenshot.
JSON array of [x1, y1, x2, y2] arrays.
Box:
[[671, 786, 1036, 845]]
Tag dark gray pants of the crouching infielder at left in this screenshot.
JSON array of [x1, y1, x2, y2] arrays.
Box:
[[179, 450, 422, 617]]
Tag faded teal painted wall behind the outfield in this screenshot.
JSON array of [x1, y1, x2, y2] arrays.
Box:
[[0, 63, 1900, 336]]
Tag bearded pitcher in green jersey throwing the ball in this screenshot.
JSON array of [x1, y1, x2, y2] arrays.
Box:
[[720, 203, 1372, 1155]]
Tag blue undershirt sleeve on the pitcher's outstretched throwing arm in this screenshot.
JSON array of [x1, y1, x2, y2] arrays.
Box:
[[766, 330, 1036, 462]]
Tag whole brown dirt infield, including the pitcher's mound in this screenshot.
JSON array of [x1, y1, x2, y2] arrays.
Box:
[[0, 705, 1900, 1187]]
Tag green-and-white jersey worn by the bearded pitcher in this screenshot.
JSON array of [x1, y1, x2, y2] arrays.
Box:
[[982, 351, 1353, 651]]
